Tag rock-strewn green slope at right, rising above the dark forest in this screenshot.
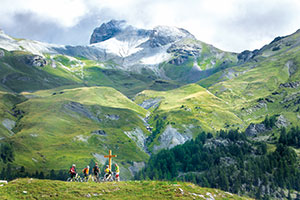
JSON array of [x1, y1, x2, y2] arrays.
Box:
[[198, 28, 300, 125]]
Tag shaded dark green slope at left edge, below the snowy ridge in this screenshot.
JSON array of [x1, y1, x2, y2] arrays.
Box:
[[0, 50, 80, 92]]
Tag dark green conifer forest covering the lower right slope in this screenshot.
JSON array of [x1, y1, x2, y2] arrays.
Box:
[[136, 129, 300, 199]]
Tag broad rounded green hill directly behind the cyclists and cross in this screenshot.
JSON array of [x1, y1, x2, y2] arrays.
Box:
[[4, 87, 148, 178]]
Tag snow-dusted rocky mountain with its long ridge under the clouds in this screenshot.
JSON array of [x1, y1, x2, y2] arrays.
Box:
[[0, 20, 237, 83]]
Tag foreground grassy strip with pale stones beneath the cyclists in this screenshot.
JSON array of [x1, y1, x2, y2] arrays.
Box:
[[0, 179, 250, 200]]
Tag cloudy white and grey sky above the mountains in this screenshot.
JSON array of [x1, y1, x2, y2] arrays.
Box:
[[0, 0, 300, 52]]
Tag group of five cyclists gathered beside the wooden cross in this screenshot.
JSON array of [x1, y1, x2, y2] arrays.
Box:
[[69, 163, 120, 181]]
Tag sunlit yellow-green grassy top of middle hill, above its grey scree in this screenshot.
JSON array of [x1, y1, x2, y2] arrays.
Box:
[[135, 84, 241, 131]]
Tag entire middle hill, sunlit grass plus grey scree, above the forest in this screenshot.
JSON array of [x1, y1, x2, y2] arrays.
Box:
[[135, 84, 243, 151]]
